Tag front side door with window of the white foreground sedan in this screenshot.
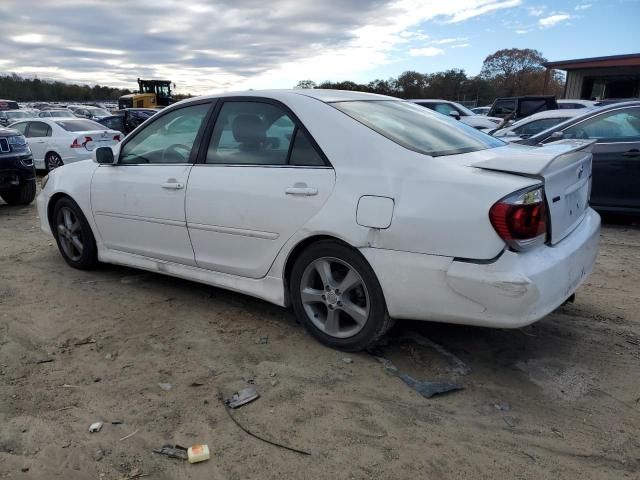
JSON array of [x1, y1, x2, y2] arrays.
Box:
[[91, 101, 211, 265]]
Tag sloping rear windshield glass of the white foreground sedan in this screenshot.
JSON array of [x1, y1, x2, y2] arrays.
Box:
[[332, 100, 504, 157]]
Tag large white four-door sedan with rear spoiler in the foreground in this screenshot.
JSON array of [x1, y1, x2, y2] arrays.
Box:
[[37, 90, 600, 351]]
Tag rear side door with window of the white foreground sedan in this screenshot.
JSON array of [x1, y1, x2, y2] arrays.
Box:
[[186, 98, 335, 278]]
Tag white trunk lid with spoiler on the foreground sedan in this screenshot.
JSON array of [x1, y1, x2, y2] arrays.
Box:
[[471, 140, 594, 245]]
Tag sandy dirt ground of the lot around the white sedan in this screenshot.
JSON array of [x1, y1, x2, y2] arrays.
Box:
[[0, 193, 640, 480]]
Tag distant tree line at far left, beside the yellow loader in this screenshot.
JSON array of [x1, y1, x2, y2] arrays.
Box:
[[0, 74, 131, 102]]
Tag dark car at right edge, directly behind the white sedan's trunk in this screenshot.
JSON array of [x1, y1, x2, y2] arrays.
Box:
[[521, 101, 640, 215]]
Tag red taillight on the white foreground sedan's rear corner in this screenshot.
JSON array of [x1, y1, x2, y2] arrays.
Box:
[[489, 187, 547, 251]]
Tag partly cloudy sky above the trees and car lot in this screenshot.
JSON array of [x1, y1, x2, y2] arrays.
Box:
[[0, 0, 640, 94]]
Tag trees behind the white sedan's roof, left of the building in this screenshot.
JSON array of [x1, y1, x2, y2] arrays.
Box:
[[296, 48, 564, 105]]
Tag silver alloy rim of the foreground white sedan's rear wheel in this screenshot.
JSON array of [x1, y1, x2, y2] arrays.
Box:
[[300, 257, 371, 338]]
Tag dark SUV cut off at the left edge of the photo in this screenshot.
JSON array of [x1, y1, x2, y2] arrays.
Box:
[[0, 127, 36, 205]]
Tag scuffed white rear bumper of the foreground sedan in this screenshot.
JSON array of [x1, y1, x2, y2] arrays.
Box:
[[361, 209, 600, 328]]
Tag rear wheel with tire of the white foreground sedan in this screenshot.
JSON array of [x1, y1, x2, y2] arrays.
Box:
[[290, 240, 392, 352]]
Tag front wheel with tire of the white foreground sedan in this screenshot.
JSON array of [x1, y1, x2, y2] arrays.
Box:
[[51, 197, 98, 270]]
